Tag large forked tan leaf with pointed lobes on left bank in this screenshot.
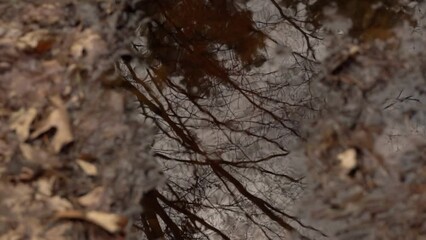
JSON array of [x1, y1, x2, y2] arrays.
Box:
[[30, 96, 74, 153]]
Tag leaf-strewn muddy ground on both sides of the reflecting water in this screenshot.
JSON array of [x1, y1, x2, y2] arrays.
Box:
[[0, 1, 426, 239]]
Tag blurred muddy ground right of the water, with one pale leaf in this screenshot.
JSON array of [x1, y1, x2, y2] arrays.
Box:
[[296, 39, 426, 240]]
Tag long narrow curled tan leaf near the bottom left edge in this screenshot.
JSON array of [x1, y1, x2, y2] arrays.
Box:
[[55, 210, 128, 233]]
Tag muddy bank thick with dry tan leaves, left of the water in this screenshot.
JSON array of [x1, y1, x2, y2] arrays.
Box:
[[0, 1, 160, 239]]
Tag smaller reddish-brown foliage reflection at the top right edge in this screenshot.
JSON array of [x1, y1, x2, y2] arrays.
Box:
[[281, 0, 415, 40]]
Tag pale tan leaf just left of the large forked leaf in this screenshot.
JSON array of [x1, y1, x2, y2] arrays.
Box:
[[10, 108, 37, 142]]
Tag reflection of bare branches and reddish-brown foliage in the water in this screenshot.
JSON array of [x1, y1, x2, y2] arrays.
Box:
[[121, 0, 420, 239]]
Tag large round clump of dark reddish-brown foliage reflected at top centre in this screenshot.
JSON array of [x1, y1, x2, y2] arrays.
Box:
[[135, 0, 265, 98]]
